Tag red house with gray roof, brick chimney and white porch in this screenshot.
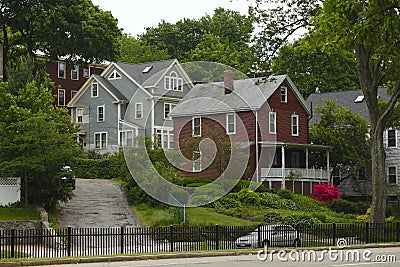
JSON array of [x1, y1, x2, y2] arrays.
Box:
[[170, 72, 330, 194]]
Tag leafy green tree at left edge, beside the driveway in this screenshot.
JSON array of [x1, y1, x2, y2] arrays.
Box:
[[0, 59, 80, 208]]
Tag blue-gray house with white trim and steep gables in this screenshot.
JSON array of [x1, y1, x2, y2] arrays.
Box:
[[68, 59, 193, 153]]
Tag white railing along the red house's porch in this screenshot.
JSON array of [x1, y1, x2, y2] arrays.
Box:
[[261, 168, 329, 181]]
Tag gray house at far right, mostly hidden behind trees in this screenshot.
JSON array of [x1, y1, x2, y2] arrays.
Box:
[[307, 88, 400, 201]]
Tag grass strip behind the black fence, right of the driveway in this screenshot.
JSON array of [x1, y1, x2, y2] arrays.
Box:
[[134, 204, 255, 226]]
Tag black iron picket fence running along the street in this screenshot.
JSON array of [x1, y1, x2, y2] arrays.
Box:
[[0, 223, 400, 259]]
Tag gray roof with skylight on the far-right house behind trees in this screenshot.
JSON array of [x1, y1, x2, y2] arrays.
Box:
[[306, 88, 390, 122]]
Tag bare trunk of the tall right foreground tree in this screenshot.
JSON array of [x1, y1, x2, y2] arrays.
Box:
[[370, 124, 386, 223]]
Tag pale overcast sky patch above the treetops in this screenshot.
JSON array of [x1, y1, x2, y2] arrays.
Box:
[[92, 0, 249, 36]]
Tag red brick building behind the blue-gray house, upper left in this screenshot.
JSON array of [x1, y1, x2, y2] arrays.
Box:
[[45, 60, 108, 106]]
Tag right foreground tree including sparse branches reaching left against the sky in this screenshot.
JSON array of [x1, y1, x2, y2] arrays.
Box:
[[253, 0, 400, 222]]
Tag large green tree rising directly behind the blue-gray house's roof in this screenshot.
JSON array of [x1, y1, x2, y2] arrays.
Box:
[[140, 8, 256, 74]]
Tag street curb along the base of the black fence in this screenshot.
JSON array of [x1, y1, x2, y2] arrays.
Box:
[[0, 243, 400, 267]]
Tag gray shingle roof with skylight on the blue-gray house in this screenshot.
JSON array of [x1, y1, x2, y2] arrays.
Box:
[[117, 59, 175, 87]]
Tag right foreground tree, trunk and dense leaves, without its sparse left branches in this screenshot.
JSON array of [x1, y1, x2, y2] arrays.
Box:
[[314, 0, 400, 225]]
